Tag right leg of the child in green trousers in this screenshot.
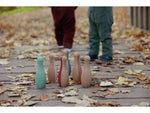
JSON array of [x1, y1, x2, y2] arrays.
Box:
[[99, 22, 113, 57]]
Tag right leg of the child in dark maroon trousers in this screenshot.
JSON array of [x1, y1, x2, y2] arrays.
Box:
[[62, 7, 75, 49]]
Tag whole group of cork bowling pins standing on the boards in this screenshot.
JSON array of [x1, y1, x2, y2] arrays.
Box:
[[35, 51, 91, 88]]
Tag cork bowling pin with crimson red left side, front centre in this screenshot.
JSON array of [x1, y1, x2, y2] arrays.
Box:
[[58, 56, 69, 87]]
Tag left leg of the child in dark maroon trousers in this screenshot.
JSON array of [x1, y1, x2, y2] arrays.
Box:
[[52, 7, 64, 46]]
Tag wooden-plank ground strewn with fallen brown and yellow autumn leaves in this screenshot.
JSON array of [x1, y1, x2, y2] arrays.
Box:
[[0, 7, 150, 106]]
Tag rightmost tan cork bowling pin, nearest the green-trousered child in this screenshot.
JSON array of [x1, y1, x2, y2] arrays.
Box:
[[81, 56, 91, 87]]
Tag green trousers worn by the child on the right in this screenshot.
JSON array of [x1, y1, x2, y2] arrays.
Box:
[[88, 7, 113, 57]]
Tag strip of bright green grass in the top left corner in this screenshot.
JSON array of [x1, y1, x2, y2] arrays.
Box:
[[0, 7, 40, 16]]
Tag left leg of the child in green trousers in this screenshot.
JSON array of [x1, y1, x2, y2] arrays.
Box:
[[88, 10, 100, 56]]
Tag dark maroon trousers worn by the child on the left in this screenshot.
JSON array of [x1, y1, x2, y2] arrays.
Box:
[[52, 7, 75, 49]]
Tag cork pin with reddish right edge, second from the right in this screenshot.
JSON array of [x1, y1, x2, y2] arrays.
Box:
[[72, 52, 82, 83]]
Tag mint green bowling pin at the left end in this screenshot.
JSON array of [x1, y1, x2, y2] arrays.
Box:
[[35, 57, 46, 88]]
